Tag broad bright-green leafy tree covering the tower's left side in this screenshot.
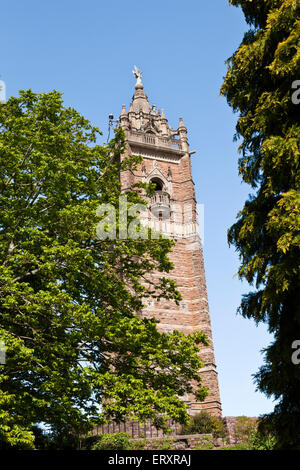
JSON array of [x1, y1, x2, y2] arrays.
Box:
[[0, 90, 207, 448]]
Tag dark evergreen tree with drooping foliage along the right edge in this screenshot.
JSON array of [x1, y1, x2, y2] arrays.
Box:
[[221, 0, 300, 449]]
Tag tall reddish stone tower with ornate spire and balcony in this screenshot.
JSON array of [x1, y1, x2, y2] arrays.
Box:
[[120, 67, 222, 416]]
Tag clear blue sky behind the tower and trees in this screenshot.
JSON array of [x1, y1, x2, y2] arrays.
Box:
[[0, 0, 274, 416]]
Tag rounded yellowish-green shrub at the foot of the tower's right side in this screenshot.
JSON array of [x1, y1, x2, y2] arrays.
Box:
[[181, 411, 226, 437]]
